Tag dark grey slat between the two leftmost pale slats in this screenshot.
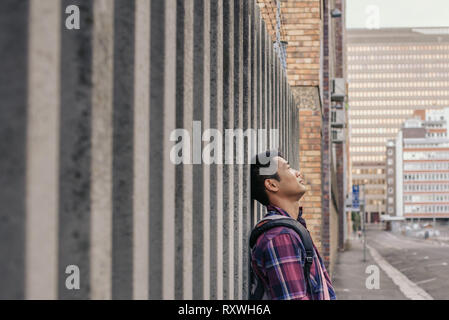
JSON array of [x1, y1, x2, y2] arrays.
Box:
[[58, 0, 93, 299]]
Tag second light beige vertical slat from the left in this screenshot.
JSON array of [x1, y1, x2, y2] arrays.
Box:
[[90, 0, 114, 299]]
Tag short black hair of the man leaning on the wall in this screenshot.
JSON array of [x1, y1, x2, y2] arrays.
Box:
[[251, 150, 282, 206]]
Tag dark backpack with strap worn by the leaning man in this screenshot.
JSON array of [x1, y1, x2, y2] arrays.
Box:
[[249, 215, 313, 300]]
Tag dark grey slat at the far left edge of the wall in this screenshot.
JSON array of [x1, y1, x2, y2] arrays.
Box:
[[0, 0, 30, 300]]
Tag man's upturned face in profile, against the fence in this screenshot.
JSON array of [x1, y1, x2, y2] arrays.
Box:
[[276, 157, 306, 200]]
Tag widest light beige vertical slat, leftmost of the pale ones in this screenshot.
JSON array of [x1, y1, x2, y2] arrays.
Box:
[[26, 0, 61, 299]]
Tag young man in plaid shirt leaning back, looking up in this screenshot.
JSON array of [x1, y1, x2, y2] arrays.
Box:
[[251, 151, 336, 300]]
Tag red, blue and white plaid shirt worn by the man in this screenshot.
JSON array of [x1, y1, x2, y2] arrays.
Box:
[[251, 206, 336, 300]]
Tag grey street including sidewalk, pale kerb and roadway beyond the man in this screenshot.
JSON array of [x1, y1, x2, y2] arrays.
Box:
[[334, 228, 449, 300]]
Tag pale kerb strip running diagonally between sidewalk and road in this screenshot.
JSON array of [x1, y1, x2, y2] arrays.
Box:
[[366, 245, 433, 300]]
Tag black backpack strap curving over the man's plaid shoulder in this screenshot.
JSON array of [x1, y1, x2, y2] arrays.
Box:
[[249, 218, 313, 300]]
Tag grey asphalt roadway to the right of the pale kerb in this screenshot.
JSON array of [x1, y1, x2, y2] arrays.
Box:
[[367, 230, 449, 300]]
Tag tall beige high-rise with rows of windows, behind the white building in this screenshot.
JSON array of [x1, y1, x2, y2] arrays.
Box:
[[346, 28, 449, 222]]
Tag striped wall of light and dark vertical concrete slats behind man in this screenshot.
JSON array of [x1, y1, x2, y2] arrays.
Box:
[[0, 0, 299, 299]]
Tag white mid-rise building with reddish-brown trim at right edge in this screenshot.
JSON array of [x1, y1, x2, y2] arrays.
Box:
[[386, 108, 449, 219]]
